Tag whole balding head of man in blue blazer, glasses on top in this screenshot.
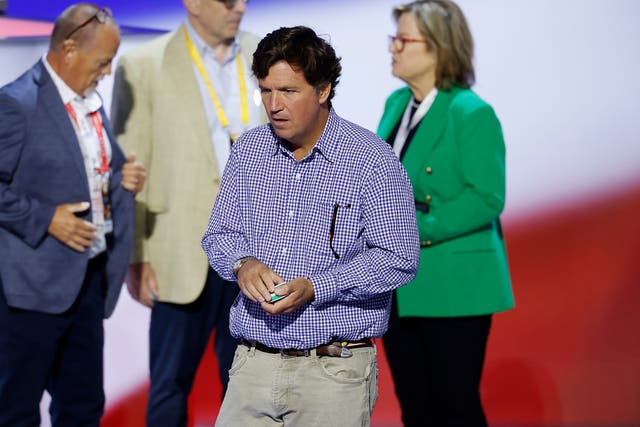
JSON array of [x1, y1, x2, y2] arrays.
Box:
[[47, 3, 120, 95]]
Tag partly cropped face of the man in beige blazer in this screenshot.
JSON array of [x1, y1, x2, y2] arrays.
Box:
[[196, 0, 246, 44]]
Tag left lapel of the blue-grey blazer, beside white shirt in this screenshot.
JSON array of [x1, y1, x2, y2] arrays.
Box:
[[36, 62, 89, 187]]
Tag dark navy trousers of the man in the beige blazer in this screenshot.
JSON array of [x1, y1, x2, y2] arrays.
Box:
[[147, 268, 238, 427]]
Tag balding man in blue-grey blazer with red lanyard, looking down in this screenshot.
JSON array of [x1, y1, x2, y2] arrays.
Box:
[[0, 3, 144, 427]]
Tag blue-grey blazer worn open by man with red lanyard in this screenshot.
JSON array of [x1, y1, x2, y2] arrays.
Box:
[[0, 61, 133, 316]]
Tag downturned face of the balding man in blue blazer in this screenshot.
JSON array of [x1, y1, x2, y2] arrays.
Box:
[[65, 24, 120, 95]]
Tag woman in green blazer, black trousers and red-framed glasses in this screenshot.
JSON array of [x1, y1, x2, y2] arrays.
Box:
[[378, 0, 514, 427]]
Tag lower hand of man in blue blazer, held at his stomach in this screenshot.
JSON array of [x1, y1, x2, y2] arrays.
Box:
[[47, 202, 97, 252]]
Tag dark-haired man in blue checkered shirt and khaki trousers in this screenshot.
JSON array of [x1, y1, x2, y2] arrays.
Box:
[[202, 27, 419, 426]]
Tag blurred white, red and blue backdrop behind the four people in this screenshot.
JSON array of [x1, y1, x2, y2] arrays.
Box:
[[0, 0, 640, 427]]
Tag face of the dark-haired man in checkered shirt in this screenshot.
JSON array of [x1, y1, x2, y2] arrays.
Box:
[[259, 61, 331, 151]]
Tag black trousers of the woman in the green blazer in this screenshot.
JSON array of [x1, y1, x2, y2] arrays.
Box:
[[383, 295, 491, 427]]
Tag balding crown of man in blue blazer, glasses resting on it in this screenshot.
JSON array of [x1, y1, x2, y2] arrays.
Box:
[[49, 3, 117, 51]]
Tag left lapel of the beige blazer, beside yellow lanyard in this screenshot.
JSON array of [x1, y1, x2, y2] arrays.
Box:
[[163, 24, 218, 170]]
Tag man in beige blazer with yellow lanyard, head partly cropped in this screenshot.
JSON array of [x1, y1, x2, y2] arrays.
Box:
[[111, 0, 266, 427]]
